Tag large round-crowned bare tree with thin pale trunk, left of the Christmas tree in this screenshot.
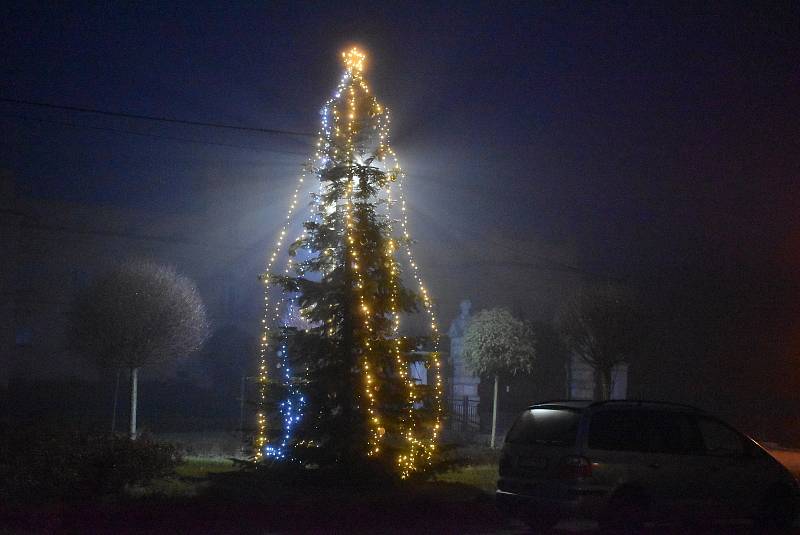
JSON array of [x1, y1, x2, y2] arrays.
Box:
[[71, 261, 208, 438]]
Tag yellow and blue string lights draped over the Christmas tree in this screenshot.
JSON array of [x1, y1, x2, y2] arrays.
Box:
[[256, 48, 442, 477]]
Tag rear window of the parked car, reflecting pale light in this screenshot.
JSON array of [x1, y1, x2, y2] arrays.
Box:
[[506, 409, 581, 446]]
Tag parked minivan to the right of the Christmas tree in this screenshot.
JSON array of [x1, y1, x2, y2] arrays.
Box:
[[496, 401, 800, 529]]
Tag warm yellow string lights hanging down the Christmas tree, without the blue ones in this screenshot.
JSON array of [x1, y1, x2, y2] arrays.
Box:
[[256, 48, 442, 477]]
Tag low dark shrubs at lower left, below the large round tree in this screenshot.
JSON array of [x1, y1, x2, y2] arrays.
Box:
[[0, 427, 181, 503]]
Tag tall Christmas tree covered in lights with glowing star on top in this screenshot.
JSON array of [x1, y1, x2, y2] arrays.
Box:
[[256, 48, 442, 477]]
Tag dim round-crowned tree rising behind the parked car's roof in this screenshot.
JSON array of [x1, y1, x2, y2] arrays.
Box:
[[557, 285, 642, 400]]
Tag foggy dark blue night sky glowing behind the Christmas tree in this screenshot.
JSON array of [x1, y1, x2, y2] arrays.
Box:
[[0, 2, 800, 406]]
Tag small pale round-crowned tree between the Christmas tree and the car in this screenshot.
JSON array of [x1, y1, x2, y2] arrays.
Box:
[[464, 308, 536, 448]]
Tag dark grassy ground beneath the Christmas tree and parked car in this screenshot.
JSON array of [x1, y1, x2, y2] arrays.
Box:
[[0, 450, 800, 535]]
